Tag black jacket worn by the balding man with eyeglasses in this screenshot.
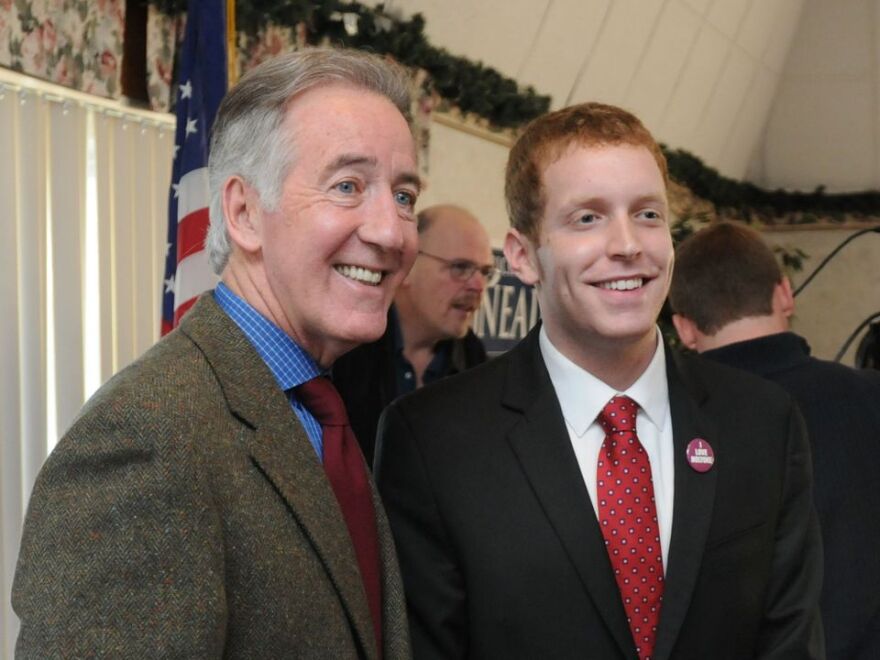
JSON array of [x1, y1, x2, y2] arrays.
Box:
[[332, 307, 487, 466]]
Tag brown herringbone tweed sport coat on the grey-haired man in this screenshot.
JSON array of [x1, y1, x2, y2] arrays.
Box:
[[13, 294, 410, 660]]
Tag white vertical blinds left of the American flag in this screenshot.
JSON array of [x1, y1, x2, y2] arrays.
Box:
[[0, 69, 174, 660]]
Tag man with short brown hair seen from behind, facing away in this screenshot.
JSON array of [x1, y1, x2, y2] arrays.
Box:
[[669, 222, 880, 660]]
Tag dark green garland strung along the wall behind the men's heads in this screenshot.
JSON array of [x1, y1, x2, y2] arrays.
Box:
[[141, 0, 880, 224]]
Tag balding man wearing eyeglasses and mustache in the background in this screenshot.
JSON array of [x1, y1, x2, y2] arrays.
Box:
[[333, 204, 498, 464]]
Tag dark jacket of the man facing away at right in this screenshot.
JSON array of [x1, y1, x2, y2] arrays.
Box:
[[704, 332, 880, 660]]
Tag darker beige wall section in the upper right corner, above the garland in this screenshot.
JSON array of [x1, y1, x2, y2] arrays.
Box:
[[749, 0, 880, 191]]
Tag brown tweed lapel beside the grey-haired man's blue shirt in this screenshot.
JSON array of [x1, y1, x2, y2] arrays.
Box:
[[180, 294, 377, 658]]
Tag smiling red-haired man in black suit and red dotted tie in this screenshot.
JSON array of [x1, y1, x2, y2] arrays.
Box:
[[375, 103, 824, 660]]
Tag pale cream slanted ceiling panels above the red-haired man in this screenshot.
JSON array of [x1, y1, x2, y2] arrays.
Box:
[[378, 0, 804, 179]]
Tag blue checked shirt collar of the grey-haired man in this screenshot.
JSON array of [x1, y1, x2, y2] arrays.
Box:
[[214, 282, 321, 391]]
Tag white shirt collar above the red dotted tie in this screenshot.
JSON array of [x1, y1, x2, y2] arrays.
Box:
[[538, 326, 669, 436]]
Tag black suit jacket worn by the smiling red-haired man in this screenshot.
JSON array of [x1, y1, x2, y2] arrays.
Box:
[[376, 328, 824, 660]]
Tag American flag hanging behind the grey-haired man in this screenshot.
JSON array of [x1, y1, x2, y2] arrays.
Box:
[[162, 0, 226, 335]]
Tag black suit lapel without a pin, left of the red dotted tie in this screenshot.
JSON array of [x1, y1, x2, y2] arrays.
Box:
[[503, 325, 633, 657]]
